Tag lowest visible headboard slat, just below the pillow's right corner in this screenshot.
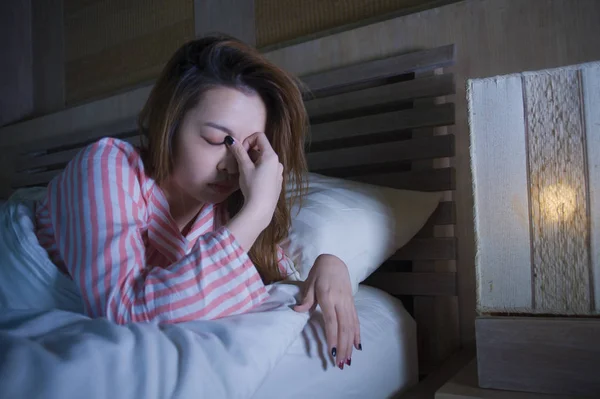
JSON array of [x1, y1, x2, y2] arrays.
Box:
[[365, 272, 457, 296]]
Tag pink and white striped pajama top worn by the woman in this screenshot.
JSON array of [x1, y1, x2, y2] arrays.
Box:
[[36, 138, 292, 324]]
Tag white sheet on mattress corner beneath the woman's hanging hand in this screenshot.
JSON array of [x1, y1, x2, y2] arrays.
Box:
[[254, 285, 418, 399]]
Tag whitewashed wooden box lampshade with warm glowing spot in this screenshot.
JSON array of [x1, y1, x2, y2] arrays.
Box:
[[469, 63, 600, 315]]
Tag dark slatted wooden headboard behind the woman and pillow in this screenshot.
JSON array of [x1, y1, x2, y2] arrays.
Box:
[[4, 45, 459, 374]]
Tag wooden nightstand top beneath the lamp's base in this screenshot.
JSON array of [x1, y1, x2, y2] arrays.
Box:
[[435, 359, 589, 399]]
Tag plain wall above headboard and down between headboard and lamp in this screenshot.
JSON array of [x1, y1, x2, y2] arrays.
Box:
[[268, 0, 600, 343]]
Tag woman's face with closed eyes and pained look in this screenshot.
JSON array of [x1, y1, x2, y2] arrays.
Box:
[[172, 87, 267, 203]]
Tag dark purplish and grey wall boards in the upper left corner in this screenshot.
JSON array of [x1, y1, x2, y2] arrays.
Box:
[[0, 0, 65, 126]]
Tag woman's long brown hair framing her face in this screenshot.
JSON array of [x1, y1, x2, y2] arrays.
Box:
[[138, 35, 308, 283]]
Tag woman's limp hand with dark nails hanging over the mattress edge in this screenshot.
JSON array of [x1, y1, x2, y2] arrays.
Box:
[[294, 254, 362, 369]]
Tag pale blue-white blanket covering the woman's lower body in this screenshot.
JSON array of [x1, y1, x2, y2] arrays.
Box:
[[0, 194, 308, 399]]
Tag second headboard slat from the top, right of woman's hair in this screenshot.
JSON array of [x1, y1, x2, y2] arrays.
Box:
[[305, 74, 455, 121]]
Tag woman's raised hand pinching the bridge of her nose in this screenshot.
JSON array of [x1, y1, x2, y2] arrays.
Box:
[[225, 133, 283, 229]]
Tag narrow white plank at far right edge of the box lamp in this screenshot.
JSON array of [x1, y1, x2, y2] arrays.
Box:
[[581, 64, 600, 313]]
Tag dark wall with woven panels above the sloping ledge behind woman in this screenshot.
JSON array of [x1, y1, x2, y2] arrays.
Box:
[[0, 0, 456, 115]]
